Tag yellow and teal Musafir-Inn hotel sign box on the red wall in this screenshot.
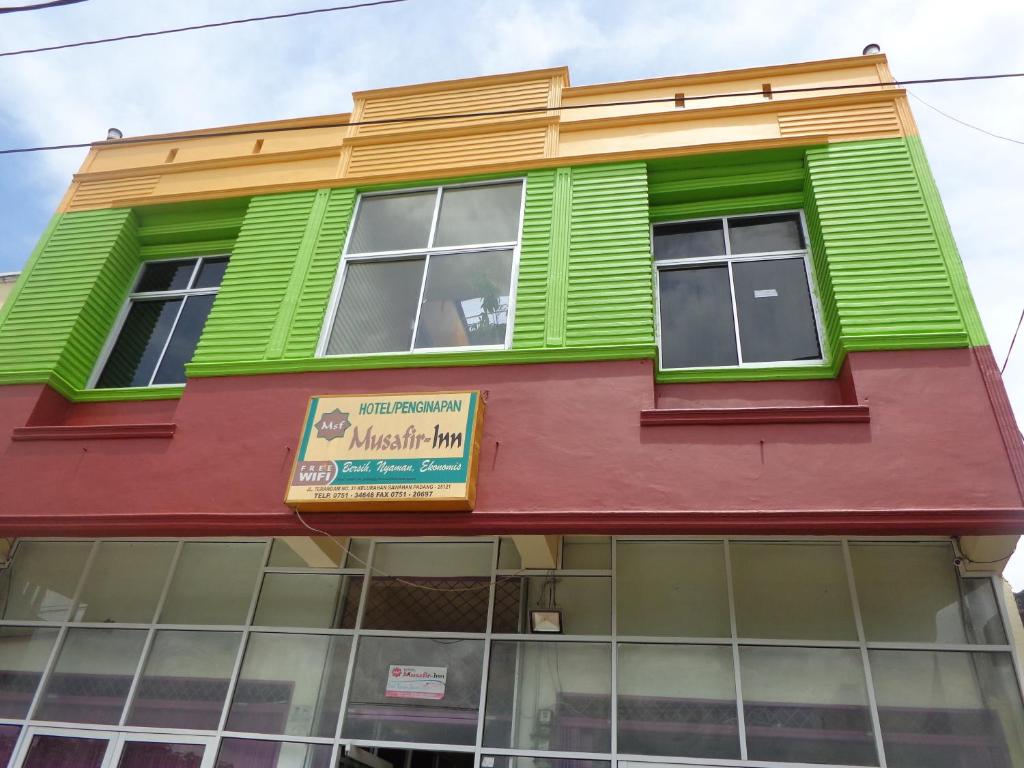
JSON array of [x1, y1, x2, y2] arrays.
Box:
[[285, 391, 483, 512]]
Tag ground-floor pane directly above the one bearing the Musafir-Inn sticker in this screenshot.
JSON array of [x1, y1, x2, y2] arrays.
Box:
[[362, 542, 494, 630]]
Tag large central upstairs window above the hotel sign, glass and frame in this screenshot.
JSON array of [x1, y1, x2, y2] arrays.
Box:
[[319, 180, 523, 355]]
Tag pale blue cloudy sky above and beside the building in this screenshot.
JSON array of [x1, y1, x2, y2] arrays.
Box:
[[0, 0, 1024, 588]]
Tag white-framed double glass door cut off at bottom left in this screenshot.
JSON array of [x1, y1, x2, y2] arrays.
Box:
[[11, 728, 214, 768]]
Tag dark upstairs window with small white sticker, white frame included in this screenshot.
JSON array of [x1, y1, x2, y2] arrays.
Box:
[[653, 212, 822, 370]]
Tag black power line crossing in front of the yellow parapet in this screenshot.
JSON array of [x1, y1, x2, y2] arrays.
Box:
[[0, 71, 1024, 155]]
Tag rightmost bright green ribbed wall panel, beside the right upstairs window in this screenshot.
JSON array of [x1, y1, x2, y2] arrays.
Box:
[[807, 139, 968, 351]]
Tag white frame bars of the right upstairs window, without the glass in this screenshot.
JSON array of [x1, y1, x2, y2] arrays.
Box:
[[650, 208, 828, 372]]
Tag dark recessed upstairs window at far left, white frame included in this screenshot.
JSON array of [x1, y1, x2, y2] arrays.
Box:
[[92, 255, 228, 389]]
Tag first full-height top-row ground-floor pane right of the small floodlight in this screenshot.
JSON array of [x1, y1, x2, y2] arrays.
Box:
[[615, 542, 731, 637]]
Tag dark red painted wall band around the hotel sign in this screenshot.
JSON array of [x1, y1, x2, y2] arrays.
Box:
[[0, 349, 1024, 536]]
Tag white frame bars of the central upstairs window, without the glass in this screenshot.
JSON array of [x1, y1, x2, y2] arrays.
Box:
[[316, 176, 526, 359]]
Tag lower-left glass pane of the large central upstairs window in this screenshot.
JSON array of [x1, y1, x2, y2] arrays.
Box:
[[327, 258, 424, 354]]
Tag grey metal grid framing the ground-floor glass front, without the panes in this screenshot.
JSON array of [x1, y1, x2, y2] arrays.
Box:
[[0, 536, 1024, 768]]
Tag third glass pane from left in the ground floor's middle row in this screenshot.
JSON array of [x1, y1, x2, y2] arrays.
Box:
[[128, 630, 242, 730]]
